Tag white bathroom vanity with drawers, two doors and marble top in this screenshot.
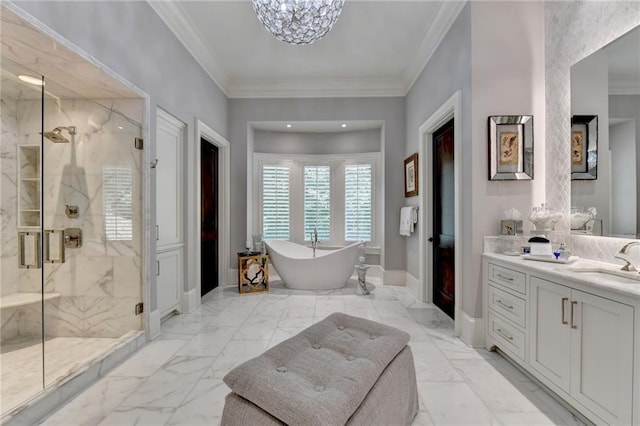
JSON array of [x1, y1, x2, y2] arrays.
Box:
[[483, 253, 640, 425]]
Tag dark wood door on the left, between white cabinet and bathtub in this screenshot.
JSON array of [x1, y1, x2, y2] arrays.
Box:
[[200, 139, 218, 296]]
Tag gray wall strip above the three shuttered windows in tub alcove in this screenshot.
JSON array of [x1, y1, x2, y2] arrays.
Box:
[[253, 129, 382, 155]]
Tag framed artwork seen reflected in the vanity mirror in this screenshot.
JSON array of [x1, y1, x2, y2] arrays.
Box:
[[571, 115, 598, 180]]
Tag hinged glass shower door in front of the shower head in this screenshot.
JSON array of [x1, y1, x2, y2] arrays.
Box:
[[42, 84, 142, 387]]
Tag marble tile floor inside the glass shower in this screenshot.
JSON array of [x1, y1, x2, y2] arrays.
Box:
[[0, 337, 118, 412]]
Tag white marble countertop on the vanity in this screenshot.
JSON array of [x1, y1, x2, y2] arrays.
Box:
[[483, 253, 640, 303]]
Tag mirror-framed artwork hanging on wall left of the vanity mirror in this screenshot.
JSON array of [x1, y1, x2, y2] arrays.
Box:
[[489, 115, 533, 180]]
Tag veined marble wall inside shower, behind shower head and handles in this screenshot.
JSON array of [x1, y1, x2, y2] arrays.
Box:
[[2, 99, 142, 339]]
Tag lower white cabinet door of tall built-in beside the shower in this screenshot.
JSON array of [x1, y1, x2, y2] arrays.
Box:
[[156, 249, 182, 318]]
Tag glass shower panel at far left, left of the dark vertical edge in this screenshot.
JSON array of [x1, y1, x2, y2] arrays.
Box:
[[0, 57, 44, 415]]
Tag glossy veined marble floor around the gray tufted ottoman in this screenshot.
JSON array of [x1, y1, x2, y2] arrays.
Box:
[[41, 281, 582, 426]]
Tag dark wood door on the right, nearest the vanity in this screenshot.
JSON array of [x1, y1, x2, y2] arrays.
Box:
[[433, 119, 455, 318]]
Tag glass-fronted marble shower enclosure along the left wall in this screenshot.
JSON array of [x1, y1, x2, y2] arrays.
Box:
[[0, 50, 143, 417]]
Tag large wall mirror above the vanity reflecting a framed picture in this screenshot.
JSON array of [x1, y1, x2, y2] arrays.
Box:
[[567, 26, 640, 238]]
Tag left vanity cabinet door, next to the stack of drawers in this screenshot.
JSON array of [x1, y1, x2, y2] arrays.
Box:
[[529, 277, 571, 393]]
